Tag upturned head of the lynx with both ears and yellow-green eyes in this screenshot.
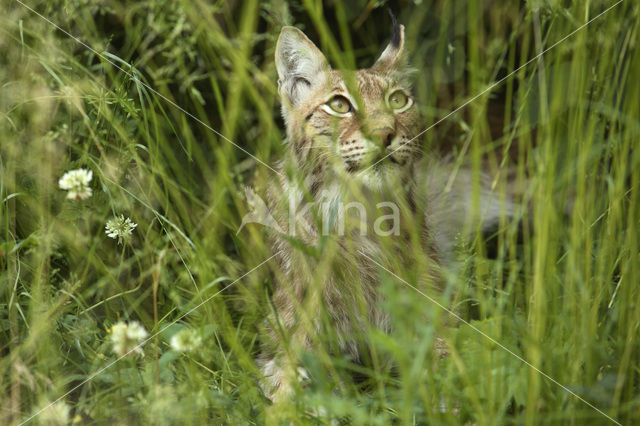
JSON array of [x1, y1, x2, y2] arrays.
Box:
[[276, 25, 421, 187]]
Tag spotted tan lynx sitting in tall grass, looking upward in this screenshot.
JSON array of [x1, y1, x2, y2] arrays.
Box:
[[257, 18, 511, 401]]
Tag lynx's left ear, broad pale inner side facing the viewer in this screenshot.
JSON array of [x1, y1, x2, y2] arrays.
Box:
[[276, 27, 329, 105]]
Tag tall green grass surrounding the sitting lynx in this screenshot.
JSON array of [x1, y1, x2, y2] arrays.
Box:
[[0, 0, 640, 425]]
